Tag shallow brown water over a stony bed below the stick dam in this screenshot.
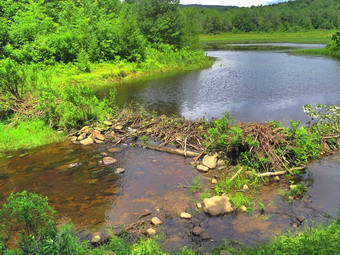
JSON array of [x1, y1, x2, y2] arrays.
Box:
[[0, 142, 340, 250]]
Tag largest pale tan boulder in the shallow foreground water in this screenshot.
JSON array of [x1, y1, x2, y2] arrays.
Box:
[[203, 196, 234, 216]]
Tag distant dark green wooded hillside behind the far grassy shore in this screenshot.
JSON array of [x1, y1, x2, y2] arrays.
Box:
[[183, 0, 340, 34]]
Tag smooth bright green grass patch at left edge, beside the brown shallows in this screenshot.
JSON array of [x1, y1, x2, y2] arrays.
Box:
[[0, 120, 65, 152]]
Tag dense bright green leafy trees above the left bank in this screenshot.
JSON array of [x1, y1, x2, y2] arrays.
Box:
[[0, 0, 197, 64]]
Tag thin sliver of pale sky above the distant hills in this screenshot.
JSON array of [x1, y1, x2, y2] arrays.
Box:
[[180, 0, 287, 7]]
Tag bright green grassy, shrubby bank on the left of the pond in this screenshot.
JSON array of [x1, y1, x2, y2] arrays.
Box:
[[0, 47, 212, 152]]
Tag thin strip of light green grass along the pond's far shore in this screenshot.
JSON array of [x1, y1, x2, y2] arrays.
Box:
[[199, 30, 334, 45]]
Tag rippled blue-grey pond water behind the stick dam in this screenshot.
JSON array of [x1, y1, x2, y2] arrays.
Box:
[[118, 44, 340, 121]]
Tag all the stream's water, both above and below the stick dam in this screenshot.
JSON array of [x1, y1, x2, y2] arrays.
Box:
[[0, 45, 340, 251]]
